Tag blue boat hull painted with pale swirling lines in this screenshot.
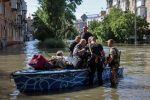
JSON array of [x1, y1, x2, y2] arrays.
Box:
[[12, 67, 123, 92]]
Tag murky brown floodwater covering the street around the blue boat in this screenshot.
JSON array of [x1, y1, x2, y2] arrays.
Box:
[[0, 41, 150, 100]]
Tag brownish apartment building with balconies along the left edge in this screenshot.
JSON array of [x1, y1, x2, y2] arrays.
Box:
[[0, 0, 27, 47]]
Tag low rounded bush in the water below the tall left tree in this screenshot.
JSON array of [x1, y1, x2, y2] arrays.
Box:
[[41, 38, 65, 48]]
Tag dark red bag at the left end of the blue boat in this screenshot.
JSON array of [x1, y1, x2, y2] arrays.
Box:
[[28, 54, 54, 70]]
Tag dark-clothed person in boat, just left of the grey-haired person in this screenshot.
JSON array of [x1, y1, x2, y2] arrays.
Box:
[[69, 36, 81, 57]]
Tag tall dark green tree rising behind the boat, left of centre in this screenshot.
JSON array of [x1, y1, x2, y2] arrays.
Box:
[[33, 0, 82, 40]]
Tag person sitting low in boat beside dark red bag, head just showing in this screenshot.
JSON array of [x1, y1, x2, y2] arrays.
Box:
[[49, 51, 73, 68]]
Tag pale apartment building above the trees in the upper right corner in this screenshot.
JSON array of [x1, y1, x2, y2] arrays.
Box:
[[107, 0, 150, 23]]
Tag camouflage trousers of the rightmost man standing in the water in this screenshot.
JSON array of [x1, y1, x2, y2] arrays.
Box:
[[110, 64, 119, 85]]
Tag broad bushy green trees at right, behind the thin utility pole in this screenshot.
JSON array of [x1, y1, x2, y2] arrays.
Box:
[[89, 7, 149, 42]]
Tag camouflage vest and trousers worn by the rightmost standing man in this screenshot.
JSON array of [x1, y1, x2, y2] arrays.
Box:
[[109, 47, 120, 85]]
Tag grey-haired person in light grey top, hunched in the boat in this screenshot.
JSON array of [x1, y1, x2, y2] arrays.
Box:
[[73, 39, 87, 68]]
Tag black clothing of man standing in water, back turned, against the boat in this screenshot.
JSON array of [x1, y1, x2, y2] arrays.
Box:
[[88, 43, 103, 85]]
